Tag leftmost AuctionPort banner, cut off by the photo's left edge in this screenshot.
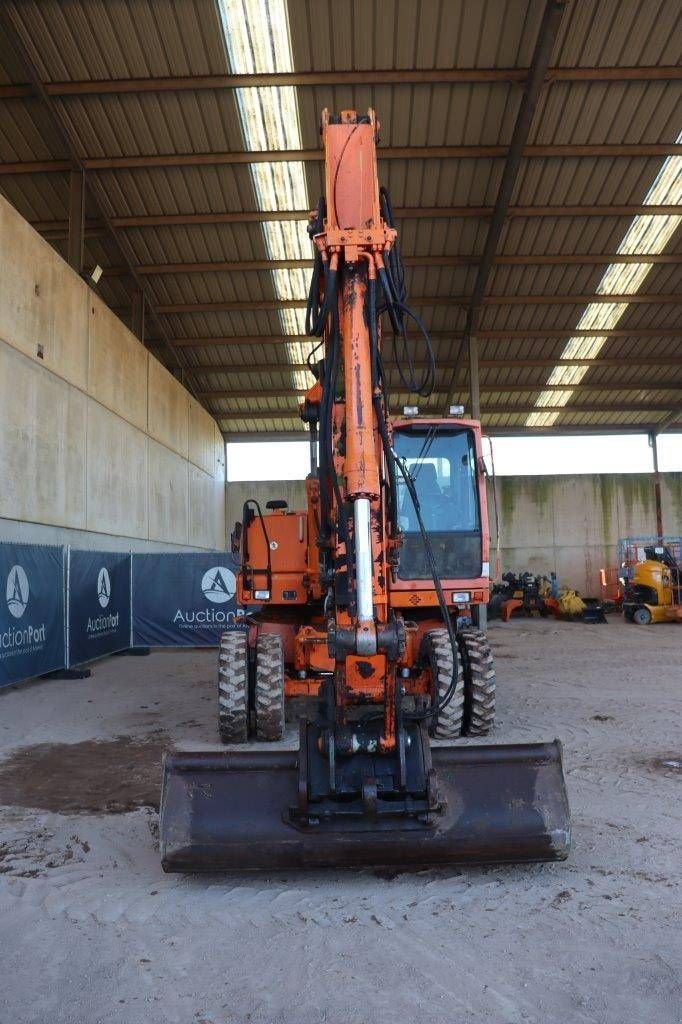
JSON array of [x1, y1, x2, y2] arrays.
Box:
[[0, 544, 66, 686]]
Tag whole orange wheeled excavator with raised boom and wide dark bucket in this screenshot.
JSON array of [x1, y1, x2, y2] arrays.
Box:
[[161, 111, 570, 871]]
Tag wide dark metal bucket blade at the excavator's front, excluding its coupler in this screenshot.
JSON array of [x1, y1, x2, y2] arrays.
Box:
[[161, 740, 570, 871]]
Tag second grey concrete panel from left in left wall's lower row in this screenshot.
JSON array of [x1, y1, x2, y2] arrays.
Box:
[[87, 399, 147, 539]]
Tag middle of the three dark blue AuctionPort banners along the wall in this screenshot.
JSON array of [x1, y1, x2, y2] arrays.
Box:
[[68, 551, 130, 666]]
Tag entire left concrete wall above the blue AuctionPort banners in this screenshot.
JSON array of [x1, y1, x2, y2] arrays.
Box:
[[0, 197, 225, 548]]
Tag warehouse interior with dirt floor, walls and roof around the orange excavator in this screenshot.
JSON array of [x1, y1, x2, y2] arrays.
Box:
[[0, 0, 682, 1024]]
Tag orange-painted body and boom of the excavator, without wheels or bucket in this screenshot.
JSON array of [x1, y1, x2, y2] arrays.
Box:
[[233, 112, 489, 750]]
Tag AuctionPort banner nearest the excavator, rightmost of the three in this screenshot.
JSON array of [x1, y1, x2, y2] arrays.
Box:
[[132, 551, 243, 647]]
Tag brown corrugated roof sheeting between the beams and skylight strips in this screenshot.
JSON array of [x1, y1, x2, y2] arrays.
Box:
[[0, 0, 682, 434]]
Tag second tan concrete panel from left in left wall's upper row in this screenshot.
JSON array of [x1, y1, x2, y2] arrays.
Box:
[[89, 294, 147, 430]]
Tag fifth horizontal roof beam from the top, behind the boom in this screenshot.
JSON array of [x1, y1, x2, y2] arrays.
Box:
[[150, 293, 682, 313]]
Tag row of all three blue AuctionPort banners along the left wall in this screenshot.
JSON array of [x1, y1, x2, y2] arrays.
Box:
[[0, 543, 246, 686]]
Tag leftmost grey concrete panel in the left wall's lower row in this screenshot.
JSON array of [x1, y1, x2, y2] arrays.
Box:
[[0, 342, 87, 528]]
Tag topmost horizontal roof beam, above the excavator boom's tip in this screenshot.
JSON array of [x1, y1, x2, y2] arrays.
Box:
[[0, 66, 682, 99]]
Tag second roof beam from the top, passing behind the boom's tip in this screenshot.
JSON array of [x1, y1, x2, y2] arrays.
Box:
[[0, 142, 682, 174]]
